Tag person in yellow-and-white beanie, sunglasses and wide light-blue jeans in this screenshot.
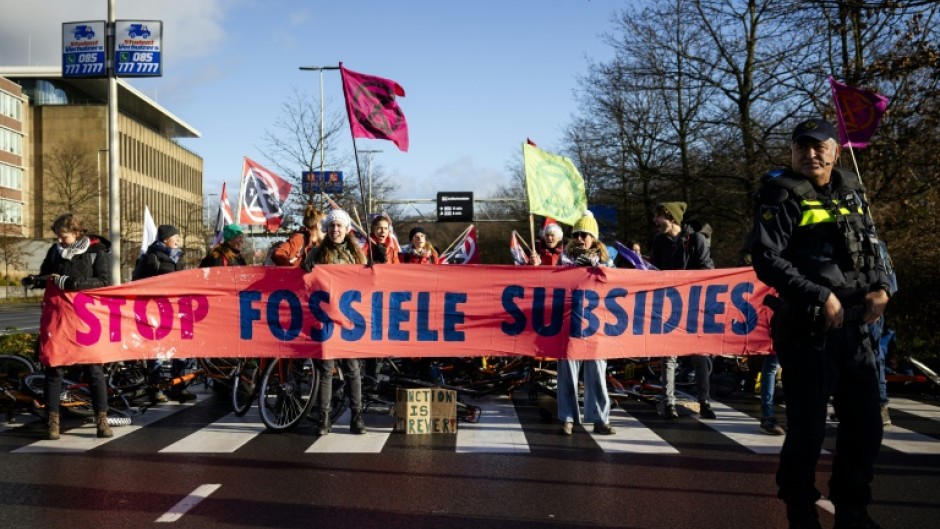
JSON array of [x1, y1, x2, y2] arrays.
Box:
[[557, 211, 616, 435]]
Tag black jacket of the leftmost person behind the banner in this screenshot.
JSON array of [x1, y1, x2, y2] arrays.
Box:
[[36, 235, 111, 290]]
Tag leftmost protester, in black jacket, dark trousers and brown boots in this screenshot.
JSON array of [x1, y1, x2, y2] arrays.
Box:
[[23, 213, 114, 440]]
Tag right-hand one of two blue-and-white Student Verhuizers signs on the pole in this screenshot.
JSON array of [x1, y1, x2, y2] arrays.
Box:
[[114, 20, 163, 77]]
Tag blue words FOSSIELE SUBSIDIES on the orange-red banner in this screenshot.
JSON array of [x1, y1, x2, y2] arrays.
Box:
[[238, 282, 759, 342]]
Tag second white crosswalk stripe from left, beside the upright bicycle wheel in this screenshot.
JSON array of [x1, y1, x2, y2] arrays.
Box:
[[160, 406, 265, 454]]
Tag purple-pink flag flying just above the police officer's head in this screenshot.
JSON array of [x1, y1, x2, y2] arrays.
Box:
[[829, 76, 888, 149]]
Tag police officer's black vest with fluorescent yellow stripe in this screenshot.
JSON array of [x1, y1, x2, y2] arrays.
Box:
[[763, 169, 887, 286]]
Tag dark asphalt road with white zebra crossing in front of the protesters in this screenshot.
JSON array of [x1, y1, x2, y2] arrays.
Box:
[[0, 384, 940, 529]]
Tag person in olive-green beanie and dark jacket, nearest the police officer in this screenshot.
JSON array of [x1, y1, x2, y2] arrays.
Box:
[[650, 202, 716, 420]]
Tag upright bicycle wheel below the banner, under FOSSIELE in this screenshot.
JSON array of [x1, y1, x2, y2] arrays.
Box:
[[258, 358, 317, 432]]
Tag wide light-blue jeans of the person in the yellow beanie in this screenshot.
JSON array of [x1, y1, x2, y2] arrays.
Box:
[[557, 360, 610, 424]]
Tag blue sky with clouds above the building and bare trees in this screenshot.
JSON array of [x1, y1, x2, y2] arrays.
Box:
[[0, 0, 630, 211]]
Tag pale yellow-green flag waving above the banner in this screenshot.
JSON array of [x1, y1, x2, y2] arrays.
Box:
[[522, 143, 587, 224]]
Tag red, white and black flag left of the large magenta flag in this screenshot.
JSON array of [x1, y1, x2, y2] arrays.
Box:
[[238, 156, 292, 232]]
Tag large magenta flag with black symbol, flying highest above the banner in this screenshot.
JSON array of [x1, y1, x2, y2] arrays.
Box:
[[339, 63, 408, 152]]
